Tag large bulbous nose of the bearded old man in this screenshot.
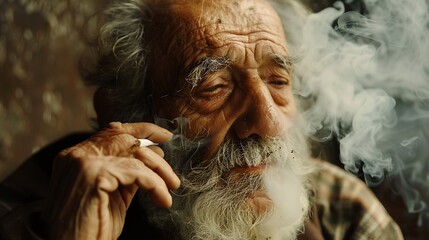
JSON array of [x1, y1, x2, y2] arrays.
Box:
[[234, 83, 287, 139]]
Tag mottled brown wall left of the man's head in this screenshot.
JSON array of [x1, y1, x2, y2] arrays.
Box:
[[0, 0, 107, 181]]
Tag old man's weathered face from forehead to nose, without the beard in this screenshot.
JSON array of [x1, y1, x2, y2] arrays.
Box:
[[153, 0, 296, 156]]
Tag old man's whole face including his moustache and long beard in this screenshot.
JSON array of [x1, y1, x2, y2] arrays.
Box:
[[146, 0, 308, 239]]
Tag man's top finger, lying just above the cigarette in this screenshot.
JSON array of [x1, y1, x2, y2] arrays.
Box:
[[107, 122, 173, 143]]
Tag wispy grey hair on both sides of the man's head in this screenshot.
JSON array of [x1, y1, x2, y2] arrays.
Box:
[[82, 0, 308, 126]]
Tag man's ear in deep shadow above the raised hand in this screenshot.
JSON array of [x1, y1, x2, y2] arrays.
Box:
[[93, 88, 115, 128]]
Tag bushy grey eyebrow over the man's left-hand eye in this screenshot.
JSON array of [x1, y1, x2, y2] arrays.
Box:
[[185, 57, 231, 87]]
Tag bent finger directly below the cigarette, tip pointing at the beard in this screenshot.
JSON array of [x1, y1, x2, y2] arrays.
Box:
[[134, 147, 180, 189]]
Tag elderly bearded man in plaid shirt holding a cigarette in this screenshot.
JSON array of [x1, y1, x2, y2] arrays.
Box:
[[2, 0, 402, 239]]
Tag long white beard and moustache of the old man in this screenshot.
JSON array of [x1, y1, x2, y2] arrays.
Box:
[[151, 121, 312, 240]]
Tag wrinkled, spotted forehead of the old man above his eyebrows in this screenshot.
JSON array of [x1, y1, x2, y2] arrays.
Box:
[[152, 0, 285, 65]]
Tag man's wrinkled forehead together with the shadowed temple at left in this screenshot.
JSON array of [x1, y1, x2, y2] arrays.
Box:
[[152, 0, 287, 96]]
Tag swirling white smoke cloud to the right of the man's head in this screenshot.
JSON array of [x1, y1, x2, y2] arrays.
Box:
[[296, 0, 429, 225]]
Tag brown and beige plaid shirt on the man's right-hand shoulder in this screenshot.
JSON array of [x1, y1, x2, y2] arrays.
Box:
[[314, 161, 403, 240]]
